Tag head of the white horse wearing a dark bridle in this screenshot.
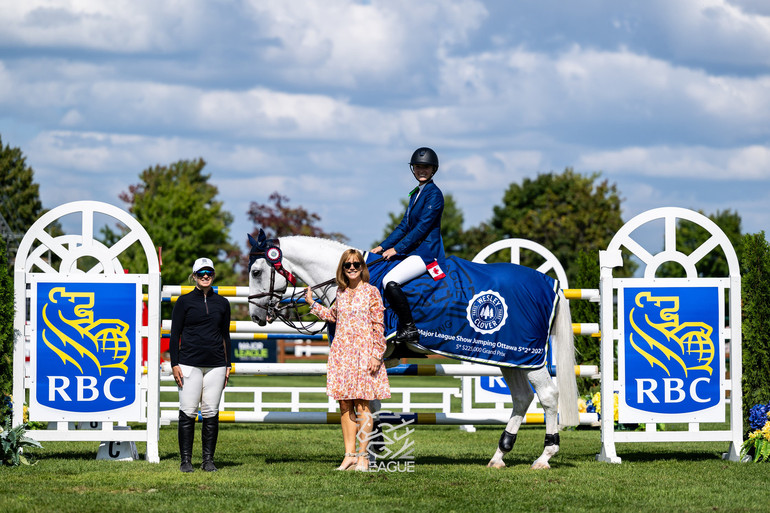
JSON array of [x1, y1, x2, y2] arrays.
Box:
[[249, 230, 295, 326]]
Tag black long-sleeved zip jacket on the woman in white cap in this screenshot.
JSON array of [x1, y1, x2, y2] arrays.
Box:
[[169, 287, 230, 367]]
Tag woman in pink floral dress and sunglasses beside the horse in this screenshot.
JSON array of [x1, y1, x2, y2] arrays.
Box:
[[305, 249, 390, 471]]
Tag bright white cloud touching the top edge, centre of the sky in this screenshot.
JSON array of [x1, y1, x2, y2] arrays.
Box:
[[240, 0, 486, 90]]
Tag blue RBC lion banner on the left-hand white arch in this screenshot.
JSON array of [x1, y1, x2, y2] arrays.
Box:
[[32, 282, 141, 420]]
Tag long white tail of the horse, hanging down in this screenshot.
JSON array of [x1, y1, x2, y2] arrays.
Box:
[[553, 290, 580, 426]]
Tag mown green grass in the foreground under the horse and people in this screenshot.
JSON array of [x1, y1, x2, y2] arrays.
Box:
[[0, 424, 770, 513]]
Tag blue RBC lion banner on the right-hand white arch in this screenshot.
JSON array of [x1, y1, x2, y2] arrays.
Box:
[[619, 287, 724, 422]]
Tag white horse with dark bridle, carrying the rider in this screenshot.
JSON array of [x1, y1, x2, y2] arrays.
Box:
[[249, 233, 578, 469]]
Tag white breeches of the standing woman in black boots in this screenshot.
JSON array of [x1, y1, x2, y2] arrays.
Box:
[[179, 364, 227, 419]]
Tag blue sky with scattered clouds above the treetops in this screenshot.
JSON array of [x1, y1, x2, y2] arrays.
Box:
[[0, 0, 770, 260]]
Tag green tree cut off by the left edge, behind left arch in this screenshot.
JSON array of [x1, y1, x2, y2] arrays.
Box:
[[0, 138, 43, 263]]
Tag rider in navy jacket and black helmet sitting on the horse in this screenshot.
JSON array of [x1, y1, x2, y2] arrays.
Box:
[[371, 148, 444, 343]]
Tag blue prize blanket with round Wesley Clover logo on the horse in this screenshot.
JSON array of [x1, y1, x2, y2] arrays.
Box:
[[367, 254, 559, 368]]
